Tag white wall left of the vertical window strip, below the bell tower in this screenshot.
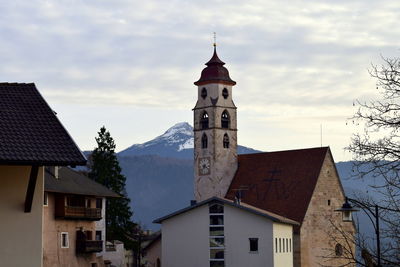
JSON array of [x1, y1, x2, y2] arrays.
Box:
[[161, 206, 210, 267]]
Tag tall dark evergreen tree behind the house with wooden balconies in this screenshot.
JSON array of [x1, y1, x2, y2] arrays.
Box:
[[89, 126, 135, 248]]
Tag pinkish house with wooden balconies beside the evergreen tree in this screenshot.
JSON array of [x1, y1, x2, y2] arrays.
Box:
[[43, 167, 119, 267]]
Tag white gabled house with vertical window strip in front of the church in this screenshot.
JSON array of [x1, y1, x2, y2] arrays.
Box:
[[154, 197, 298, 267]]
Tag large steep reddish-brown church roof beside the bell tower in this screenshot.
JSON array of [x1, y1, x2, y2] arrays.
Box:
[[226, 147, 329, 227]]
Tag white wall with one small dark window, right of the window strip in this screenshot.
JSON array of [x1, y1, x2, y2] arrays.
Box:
[[224, 205, 276, 267]]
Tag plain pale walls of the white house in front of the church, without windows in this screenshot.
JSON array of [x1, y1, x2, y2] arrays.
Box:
[[161, 205, 293, 267]]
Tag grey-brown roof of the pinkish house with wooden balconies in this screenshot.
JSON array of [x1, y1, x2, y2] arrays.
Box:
[[44, 167, 120, 197]]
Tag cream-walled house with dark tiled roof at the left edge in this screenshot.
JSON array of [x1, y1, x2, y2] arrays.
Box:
[[0, 83, 86, 267]]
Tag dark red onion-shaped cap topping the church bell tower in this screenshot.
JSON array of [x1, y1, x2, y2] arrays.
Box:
[[194, 47, 236, 86]]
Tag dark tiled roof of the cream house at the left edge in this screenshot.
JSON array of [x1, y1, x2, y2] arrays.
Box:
[[0, 83, 86, 166]]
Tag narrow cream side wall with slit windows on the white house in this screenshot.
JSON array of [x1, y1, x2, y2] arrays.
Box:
[[273, 223, 293, 267]]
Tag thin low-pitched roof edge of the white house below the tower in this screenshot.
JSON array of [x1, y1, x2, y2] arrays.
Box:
[[153, 197, 299, 225]]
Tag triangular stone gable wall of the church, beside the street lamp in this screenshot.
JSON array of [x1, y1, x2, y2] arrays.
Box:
[[294, 152, 355, 267]]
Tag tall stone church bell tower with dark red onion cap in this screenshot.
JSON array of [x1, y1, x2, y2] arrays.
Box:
[[193, 44, 238, 201]]
